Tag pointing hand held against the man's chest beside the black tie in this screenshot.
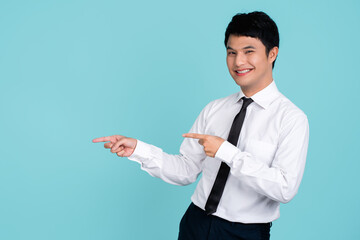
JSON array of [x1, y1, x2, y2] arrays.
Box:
[[183, 133, 225, 157]]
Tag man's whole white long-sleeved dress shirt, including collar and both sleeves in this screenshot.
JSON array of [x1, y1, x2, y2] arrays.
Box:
[[129, 81, 309, 223]]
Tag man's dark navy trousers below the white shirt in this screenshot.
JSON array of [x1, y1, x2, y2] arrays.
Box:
[[178, 203, 271, 240]]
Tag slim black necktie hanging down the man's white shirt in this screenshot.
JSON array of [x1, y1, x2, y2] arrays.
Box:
[[205, 97, 253, 215]]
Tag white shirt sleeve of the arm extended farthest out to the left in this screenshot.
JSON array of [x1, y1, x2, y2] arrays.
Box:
[[129, 104, 214, 185]]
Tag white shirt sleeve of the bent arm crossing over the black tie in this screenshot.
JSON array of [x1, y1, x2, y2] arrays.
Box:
[[215, 111, 309, 203]]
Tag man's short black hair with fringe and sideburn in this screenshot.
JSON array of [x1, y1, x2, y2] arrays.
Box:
[[224, 11, 280, 68]]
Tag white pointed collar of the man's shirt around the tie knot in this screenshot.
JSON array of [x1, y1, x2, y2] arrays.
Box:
[[236, 80, 280, 109]]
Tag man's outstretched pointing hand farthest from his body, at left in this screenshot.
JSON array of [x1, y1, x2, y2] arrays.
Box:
[[93, 135, 137, 157]]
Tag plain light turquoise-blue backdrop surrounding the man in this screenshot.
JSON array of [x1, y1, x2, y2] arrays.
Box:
[[0, 0, 360, 240]]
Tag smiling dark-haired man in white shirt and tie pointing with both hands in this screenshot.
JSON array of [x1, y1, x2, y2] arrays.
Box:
[[93, 12, 309, 240]]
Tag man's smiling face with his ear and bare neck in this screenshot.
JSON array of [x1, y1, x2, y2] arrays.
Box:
[[226, 35, 278, 97]]
